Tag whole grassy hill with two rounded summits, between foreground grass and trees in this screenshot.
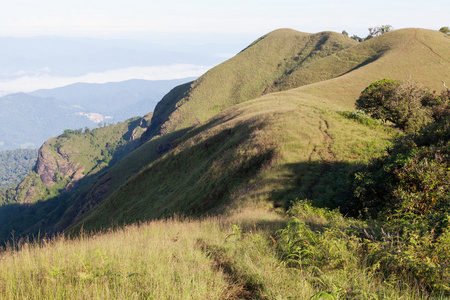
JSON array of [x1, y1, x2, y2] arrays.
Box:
[[1, 29, 450, 239]]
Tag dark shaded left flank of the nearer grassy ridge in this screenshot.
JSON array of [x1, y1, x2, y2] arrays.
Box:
[[72, 121, 274, 231]]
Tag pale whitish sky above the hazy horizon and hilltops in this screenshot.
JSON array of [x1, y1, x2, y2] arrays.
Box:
[[0, 0, 450, 37]]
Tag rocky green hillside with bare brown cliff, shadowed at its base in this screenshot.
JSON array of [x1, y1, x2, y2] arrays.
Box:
[[0, 114, 151, 241]]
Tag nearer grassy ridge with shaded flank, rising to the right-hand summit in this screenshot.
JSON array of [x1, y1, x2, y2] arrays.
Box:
[[71, 29, 450, 229]]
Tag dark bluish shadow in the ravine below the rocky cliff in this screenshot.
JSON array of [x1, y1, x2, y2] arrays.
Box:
[[0, 123, 195, 245]]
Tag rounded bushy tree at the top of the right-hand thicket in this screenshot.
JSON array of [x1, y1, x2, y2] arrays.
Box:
[[356, 79, 432, 132]]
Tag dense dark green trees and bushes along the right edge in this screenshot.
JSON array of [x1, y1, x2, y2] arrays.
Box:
[[341, 79, 450, 295]]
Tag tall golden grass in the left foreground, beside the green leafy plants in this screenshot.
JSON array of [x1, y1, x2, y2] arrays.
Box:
[[0, 210, 320, 299]]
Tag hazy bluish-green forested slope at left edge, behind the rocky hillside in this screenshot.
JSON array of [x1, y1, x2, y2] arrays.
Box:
[[0, 149, 38, 190]]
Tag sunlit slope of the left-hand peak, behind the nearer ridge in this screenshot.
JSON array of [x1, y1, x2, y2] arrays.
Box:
[[142, 29, 357, 139]]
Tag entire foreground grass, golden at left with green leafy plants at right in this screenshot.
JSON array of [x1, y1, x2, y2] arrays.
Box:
[[0, 202, 438, 299]]
